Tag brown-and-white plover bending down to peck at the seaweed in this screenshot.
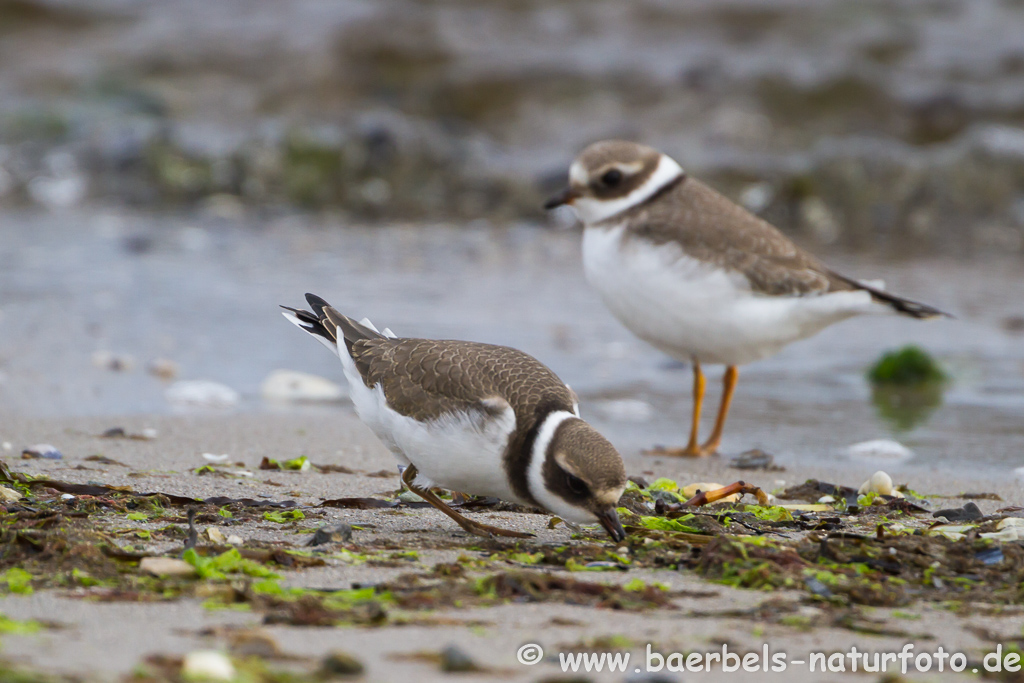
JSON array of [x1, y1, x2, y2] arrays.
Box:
[[282, 294, 626, 541]]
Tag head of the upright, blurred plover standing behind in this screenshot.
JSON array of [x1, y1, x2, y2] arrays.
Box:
[[544, 140, 683, 225]]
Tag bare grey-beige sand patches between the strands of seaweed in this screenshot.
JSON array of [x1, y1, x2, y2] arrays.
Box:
[[0, 413, 1024, 681]]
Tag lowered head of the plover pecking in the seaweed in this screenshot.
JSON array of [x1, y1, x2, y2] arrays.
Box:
[[528, 412, 626, 541]]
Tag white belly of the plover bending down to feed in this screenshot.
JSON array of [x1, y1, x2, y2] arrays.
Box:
[[339, 344, 523, 503]]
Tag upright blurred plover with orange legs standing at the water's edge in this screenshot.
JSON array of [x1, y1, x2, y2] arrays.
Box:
[[545, 140, 945, 456]]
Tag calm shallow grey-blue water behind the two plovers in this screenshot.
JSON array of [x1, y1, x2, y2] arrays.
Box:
[[0, 210, 1024, 473]]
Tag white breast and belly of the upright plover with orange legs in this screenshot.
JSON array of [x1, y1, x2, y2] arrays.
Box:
[[583, 224, 885, 365]]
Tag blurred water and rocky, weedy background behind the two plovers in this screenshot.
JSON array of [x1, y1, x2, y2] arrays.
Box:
[[0, 0, 1024, 471]]
